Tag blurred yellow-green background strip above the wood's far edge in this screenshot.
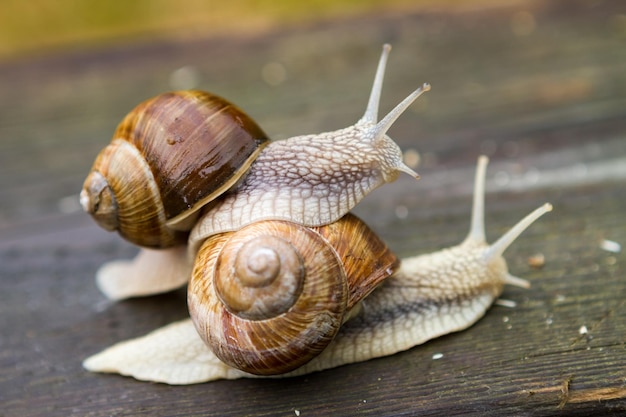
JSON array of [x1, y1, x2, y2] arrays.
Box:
[[0, 0, 454, 58]]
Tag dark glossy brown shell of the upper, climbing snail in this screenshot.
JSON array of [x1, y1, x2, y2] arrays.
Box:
[[81, 91, 269, 247]]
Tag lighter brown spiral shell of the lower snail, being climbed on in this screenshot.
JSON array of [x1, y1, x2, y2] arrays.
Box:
[[188, 214, 398, 375]]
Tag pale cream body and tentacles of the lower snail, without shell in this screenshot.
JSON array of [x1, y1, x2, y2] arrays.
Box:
[[83, 157, 552, 385]]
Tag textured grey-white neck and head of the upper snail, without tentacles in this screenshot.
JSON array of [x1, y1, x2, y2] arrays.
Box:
[[190, 120, 420, 245]]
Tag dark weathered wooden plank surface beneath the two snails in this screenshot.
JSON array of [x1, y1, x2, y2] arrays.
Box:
[[0, 1, 626, 416]]
